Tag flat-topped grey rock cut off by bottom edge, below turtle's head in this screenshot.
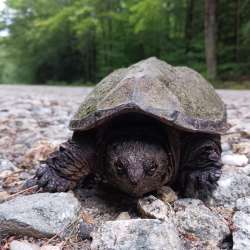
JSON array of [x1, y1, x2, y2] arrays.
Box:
[[91, 219, 183, 250]]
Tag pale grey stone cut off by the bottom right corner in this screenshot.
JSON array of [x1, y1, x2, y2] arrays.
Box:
[[233, 211, 250, 250]]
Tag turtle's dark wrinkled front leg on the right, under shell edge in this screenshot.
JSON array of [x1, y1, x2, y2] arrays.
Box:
[[180, 134, 222, 198]]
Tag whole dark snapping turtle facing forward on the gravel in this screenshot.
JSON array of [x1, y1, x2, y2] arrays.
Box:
[[27, 58, 227, 196]]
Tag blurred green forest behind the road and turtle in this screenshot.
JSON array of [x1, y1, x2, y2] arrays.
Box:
[[0, 0, 250, 88]]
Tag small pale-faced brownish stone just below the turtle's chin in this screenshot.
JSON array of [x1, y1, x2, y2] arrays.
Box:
[[137, 195, 170, 220]]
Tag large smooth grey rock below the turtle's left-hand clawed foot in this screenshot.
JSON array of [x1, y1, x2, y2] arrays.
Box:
[[0, 193, 81, 237]]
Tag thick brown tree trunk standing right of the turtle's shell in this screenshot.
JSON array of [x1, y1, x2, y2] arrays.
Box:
[[205, 0, 217, 79]]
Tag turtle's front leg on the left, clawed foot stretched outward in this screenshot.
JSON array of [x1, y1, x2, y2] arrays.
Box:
[[25, 137, 95, 192]]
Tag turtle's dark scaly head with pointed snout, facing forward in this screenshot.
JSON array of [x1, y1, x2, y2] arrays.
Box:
[[105, 137, 173, 196]]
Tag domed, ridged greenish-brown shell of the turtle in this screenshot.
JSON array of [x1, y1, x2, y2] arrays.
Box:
[[70, 57, 227, 134]]
